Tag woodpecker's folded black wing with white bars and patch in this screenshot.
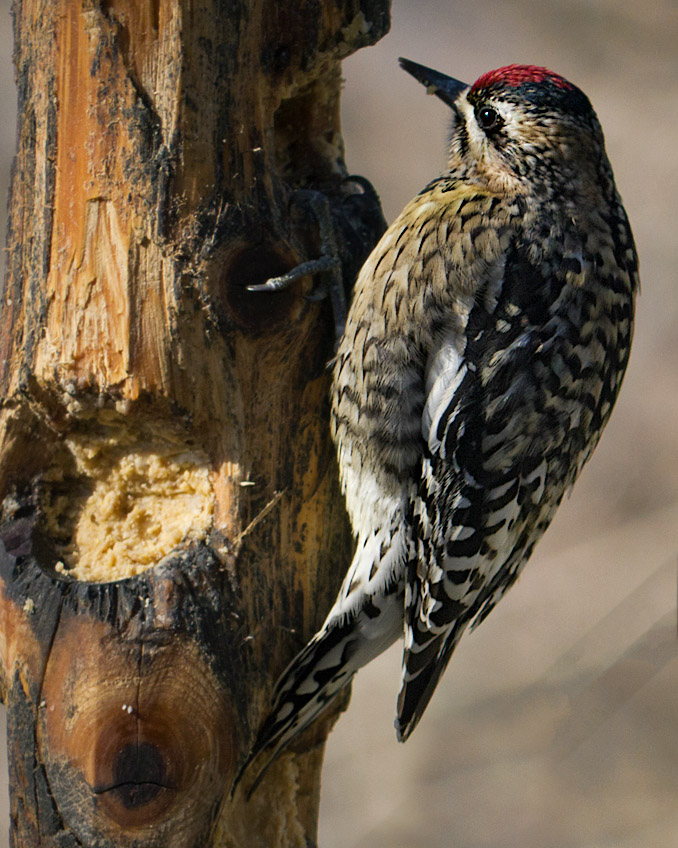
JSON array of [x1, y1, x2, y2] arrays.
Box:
[[396, 242, 601, 740]]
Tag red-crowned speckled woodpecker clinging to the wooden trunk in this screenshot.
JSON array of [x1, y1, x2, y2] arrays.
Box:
[[240, 59, 639, 788]]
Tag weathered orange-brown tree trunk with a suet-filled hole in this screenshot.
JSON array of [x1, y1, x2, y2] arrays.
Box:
[[0, 0, 388, 848]]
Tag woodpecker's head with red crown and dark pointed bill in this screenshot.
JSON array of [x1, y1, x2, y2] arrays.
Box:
[[400, 59, 609, 200]]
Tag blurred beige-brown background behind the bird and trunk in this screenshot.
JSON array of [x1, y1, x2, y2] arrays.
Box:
[[0, 0, 678, 848]]
